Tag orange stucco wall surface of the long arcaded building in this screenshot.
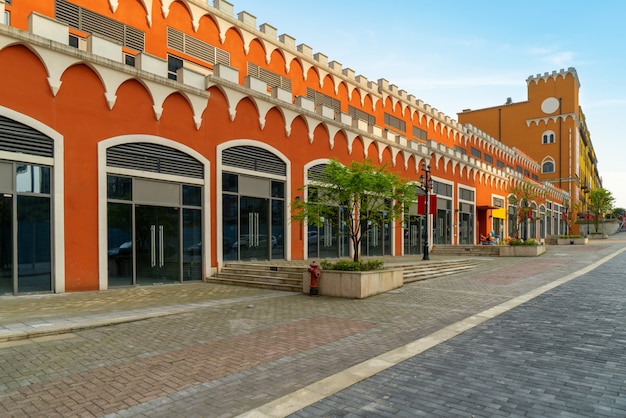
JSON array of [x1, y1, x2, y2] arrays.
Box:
[[0, 0, 564, 291]]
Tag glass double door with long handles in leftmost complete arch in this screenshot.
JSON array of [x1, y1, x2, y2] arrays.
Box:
[[135, 205, 181, 285]]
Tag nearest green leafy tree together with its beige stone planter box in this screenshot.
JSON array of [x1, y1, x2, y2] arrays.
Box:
[[292, 160, 416, 298]]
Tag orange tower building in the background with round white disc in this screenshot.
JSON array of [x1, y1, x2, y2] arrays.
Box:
[[458, 68, 602, 233]]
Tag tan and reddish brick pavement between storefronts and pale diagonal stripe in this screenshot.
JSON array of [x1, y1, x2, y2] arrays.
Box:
[[0, 235, 626, 417]]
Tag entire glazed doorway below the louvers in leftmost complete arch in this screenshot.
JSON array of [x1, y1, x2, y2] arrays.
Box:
[[107, 175, 203, 286]]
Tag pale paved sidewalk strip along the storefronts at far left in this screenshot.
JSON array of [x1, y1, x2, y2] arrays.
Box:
[[0, 255, 478, 343]]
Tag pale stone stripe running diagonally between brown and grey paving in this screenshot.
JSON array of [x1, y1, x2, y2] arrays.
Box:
[[237, 248, 626, 418]]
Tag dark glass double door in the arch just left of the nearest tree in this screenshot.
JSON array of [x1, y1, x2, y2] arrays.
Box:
[[233, 196, 268, 261]]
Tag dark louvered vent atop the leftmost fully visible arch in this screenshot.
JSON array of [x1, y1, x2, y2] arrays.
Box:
[[107, 143, 204, 179]]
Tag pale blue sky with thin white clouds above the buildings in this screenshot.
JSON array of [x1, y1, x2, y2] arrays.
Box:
[[229, 0, 626, 208]]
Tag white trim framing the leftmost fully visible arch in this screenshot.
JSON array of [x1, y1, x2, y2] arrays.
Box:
[[98, 135, 213, 290]]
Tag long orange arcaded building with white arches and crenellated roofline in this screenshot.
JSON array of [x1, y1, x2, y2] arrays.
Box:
[[0, 0, 568, 294]]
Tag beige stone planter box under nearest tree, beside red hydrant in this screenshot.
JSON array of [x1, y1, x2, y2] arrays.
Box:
[[302, 268, 404, 299]]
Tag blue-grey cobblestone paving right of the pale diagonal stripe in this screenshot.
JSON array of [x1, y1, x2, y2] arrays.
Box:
[[286, 240, 626, 418]]
